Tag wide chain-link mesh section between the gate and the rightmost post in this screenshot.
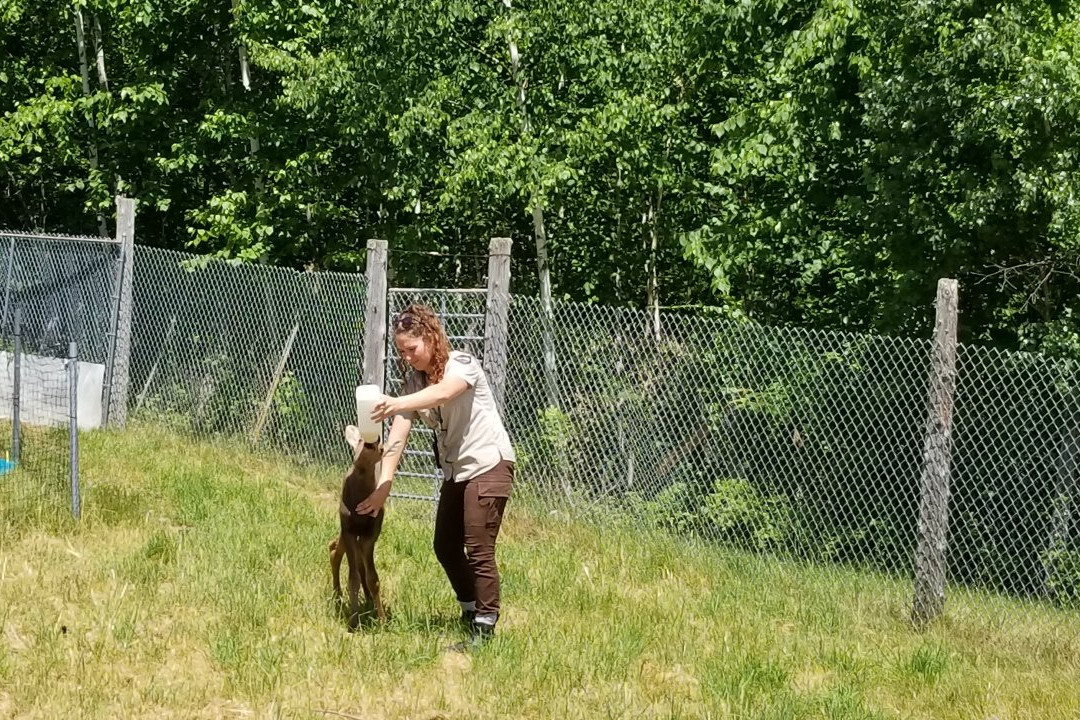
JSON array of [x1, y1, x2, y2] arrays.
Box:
[[508, 299, 929, 572]]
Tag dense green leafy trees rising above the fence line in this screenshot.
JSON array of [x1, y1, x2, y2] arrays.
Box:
[[0, 0, 1080, 357]]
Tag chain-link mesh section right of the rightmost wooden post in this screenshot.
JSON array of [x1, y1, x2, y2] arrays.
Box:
[[949, 347, 1080, 609]]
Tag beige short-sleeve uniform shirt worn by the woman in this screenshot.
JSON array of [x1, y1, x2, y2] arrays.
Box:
[[402, 350, 516, 483]]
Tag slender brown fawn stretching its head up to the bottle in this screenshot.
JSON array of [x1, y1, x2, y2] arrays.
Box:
[[329, 425, 387, 629]]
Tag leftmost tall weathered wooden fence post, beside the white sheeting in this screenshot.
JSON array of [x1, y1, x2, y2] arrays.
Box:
[[102, 195, 135, 427]]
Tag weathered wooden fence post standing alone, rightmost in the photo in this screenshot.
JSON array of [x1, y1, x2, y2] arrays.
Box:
[[912, 279, 958, 628]]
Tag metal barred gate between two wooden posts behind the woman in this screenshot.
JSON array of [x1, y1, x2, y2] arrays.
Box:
[[386, 287, 487, 501]]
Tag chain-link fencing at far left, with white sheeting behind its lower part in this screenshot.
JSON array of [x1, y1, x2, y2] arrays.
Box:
[[0, 231, 108, 524]]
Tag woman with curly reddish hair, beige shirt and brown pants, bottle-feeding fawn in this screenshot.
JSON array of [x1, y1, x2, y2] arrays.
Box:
[[356, 304, 515, 646]]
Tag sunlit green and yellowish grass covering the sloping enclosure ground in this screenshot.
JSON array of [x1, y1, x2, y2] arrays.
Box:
[[0, 426, 1080, 720]]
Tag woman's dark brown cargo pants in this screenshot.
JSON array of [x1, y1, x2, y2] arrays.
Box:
[[434, 460, 514, 614]]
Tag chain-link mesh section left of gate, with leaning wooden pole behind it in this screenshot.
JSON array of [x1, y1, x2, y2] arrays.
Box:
[[131, 247, 367, 462]]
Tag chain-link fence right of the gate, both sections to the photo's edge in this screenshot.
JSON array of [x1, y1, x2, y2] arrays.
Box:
[[507, 298, 1080, 610]]
